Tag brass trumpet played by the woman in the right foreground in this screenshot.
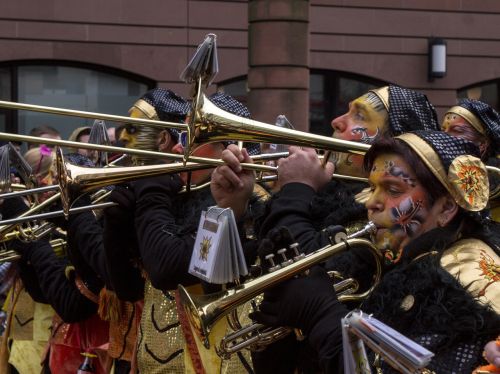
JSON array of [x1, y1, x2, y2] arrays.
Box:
[[178, 222, 382, 357]]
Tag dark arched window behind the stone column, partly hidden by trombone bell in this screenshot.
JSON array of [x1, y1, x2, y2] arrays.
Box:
[[218, 70, 388, 136]]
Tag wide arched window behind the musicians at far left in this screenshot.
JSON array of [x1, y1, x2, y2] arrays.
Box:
[[0, 64, 154, 139]]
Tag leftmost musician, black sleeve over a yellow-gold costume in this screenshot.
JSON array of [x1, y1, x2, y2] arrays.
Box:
[[1, 145, 96, 372]]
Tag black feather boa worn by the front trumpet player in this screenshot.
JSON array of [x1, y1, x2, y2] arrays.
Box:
[[361, 228, 500, 353]]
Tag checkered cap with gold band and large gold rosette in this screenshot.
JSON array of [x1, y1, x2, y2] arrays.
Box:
[[396, 131, 489, 212]]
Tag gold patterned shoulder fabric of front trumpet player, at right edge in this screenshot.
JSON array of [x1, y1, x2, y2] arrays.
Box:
[[441, 239, 500, 313]]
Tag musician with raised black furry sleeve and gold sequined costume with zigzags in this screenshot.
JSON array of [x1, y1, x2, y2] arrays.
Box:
[[125, 93, 258, 373]]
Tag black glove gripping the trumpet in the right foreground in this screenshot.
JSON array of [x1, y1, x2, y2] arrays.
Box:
[[250, 266, 340, 335]]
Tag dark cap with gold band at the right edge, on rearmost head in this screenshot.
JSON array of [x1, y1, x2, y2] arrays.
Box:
[[448, 99, 500, 153]]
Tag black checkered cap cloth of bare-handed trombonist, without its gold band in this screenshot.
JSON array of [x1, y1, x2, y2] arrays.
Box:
[[389, 85, 440, 136]]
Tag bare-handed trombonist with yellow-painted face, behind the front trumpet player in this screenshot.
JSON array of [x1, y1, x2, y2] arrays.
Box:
[[212, 85, 439, 373]]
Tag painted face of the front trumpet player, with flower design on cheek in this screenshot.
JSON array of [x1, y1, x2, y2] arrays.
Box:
[[366, 154, 437, 262]]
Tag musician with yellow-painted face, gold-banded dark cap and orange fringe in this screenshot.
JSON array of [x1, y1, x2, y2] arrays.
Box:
[[61, 89, 192, 373]]
